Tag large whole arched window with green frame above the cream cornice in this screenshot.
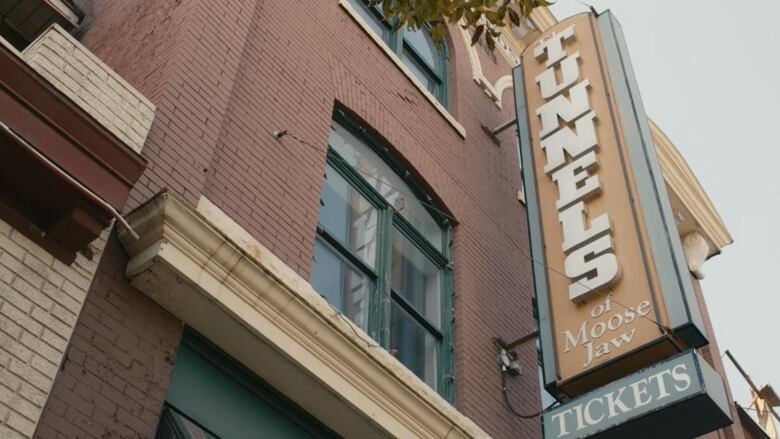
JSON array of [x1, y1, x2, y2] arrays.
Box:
[[311, 117, 452, 399]]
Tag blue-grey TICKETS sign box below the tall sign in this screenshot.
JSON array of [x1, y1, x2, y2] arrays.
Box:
[[542, 351, 732, 439]]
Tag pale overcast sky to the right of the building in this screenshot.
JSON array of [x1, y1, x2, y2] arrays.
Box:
[[550, 0, 780, 412]]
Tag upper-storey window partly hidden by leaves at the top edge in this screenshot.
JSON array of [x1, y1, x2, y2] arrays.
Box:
[[349, 0, 447, 107]]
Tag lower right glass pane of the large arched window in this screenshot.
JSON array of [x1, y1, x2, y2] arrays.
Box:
[[390, 303, 439, 389]]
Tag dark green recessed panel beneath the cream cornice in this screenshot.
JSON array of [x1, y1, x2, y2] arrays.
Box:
[[157, 333, 336, 439]]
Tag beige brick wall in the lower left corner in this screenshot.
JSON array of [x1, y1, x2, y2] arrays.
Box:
[[0, 220, 108, 439]]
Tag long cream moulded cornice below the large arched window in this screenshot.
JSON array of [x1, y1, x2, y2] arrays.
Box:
[[120, 193, 488, 438]]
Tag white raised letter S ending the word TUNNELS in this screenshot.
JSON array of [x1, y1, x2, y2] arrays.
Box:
[[564, 235, 620, 302]]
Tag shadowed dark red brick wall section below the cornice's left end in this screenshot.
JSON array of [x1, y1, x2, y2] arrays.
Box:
[[35, 237, 182, 439]]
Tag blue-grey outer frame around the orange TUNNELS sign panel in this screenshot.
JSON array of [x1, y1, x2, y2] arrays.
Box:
[[513, 11, 708, 398]]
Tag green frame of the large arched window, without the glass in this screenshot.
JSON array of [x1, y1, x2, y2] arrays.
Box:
[[311, 111, 454, 402]]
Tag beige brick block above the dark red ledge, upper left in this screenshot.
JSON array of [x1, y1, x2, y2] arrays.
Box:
[[22, 25, 155, 154]]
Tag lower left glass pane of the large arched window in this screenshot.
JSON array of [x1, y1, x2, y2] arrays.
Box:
[[311, 238, 370, 329]]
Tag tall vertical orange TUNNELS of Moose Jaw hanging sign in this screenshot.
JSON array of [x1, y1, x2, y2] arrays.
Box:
[[513, 12, 707, 397]]
